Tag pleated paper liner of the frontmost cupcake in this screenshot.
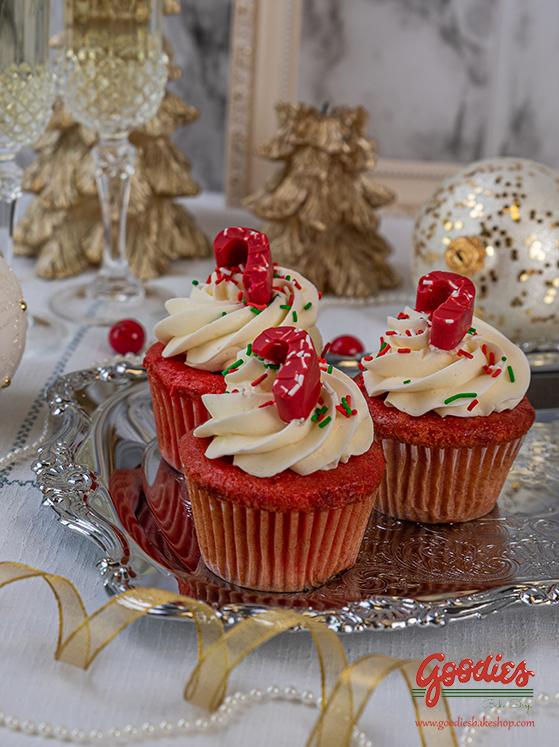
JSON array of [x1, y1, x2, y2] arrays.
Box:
[[186, 475, 376, 592]]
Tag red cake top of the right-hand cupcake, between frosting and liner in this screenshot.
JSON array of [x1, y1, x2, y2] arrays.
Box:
[[355, 375, 536, 449]]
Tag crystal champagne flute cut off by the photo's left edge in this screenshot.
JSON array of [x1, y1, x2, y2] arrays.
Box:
[[0, 0, 67, 355]]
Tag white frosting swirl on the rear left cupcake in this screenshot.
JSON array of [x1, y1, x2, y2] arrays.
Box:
[[154, 266, 322, 371]]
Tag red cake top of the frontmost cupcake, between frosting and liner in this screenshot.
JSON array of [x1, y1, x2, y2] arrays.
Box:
[[179, 433, 384, 512]]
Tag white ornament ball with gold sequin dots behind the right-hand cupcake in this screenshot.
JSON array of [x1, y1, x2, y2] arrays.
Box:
[[412, 158, 559, 345]]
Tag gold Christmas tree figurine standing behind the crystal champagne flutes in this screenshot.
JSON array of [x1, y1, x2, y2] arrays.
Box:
[[14, 0, 211, 280]]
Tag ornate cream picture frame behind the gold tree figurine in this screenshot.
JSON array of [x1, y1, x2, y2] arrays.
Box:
[[225, 0, 462, 217]]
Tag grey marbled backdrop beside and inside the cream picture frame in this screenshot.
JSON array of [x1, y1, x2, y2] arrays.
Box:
[[49, 0, 559, 190]]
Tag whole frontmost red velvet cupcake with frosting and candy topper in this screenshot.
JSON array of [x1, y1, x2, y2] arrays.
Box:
[[180, 327, 384, 592]]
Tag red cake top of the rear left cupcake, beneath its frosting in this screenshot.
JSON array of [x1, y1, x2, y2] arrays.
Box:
[[144, 342, 225, 396]]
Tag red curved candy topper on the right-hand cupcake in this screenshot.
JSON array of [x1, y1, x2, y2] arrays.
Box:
[[415, 271, 476, 350]]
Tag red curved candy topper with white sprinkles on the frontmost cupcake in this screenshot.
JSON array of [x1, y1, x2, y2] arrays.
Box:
[[252, 327, 321, 423]]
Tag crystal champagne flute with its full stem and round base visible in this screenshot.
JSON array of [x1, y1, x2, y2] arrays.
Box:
[[50, 0, 168, 325]]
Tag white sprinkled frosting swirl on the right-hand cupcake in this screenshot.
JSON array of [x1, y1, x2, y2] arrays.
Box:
[[361, 308, 530, 418]]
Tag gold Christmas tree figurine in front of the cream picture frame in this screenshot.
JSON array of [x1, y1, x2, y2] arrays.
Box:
[[243, 102, 400, 297]]
